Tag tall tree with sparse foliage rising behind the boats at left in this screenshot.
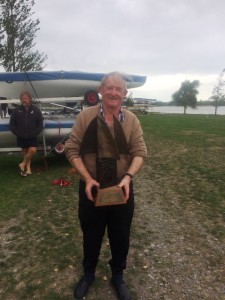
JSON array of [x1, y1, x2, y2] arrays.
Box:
[[0, 0, 47, 72]]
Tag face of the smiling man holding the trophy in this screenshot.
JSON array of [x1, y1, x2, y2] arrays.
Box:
[[99, 78, 127, 108]]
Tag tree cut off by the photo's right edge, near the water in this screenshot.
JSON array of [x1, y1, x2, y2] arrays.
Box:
[[210, 69, 225, 115]]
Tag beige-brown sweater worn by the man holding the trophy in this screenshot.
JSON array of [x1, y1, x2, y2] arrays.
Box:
[[65, 105, 147, 181]]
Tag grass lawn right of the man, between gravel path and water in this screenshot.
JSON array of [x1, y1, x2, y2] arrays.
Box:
[[141, 115, 225, 232]]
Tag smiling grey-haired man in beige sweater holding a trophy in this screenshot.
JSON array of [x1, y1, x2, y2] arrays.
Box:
[[66, 72, 147, 300]]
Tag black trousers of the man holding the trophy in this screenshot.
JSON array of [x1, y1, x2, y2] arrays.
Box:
[[78, 180, 134, 273]]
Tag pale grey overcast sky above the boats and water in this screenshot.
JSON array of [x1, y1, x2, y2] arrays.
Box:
[[30, 0, 225, 101]]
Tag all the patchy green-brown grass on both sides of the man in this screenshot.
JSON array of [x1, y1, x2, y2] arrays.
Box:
[[0, 114, 225, 300]]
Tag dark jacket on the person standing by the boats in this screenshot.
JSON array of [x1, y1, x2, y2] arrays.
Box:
[[9, 104, 43, 139]]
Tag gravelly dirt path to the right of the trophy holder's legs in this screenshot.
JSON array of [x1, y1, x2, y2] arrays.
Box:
[[127, 166, 225, 300]]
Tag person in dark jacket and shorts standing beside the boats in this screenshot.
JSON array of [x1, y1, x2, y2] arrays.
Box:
[[10, 92, 43, 177]]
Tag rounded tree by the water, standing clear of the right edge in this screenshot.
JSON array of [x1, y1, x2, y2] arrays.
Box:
[[172, 80, 200, 114]]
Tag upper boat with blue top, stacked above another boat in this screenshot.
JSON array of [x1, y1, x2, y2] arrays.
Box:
[[0, 71, 146, 105]]
